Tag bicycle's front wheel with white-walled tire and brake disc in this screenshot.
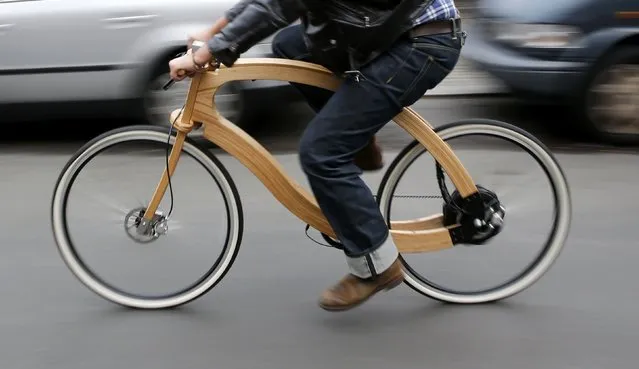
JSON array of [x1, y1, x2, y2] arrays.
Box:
[[51, 126, 243, 309]]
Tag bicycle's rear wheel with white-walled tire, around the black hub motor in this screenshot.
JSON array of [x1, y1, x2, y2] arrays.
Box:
[[377, 119, 571, 304]]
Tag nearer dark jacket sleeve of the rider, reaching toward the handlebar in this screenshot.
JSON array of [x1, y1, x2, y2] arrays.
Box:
[[208, 0, 303, 67]]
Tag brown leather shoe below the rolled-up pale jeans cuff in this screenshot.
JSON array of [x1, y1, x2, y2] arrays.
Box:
[[319, 259, 404, 311]]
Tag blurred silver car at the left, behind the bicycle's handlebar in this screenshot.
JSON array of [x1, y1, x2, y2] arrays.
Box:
[[0, 0, 284, 128]]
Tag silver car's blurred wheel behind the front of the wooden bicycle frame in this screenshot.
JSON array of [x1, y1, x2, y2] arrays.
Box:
[[143, 62, 246, 137]]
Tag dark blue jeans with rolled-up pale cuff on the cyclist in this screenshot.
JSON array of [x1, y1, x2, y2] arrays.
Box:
[[273, 25, 461, 278]]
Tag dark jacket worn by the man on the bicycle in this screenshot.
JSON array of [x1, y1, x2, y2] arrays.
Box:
[[208, 0, 430, 73]]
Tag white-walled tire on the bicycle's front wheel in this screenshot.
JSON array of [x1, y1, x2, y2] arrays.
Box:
[[51, 126, 243, 309]]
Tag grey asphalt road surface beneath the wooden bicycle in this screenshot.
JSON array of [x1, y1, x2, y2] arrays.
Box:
[[0, 99, 639, 369]]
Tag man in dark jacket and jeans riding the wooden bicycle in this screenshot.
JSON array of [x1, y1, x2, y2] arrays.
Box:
[[169, 0, 465, 311]]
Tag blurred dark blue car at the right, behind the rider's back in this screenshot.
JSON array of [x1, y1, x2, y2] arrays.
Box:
[[464, 0, 639, 144]]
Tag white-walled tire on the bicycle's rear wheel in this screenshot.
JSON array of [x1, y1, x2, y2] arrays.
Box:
[[377, 119, 571, 304]]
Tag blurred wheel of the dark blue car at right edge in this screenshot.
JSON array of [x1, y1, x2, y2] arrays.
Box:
[[580, 46, 639, 144]]
